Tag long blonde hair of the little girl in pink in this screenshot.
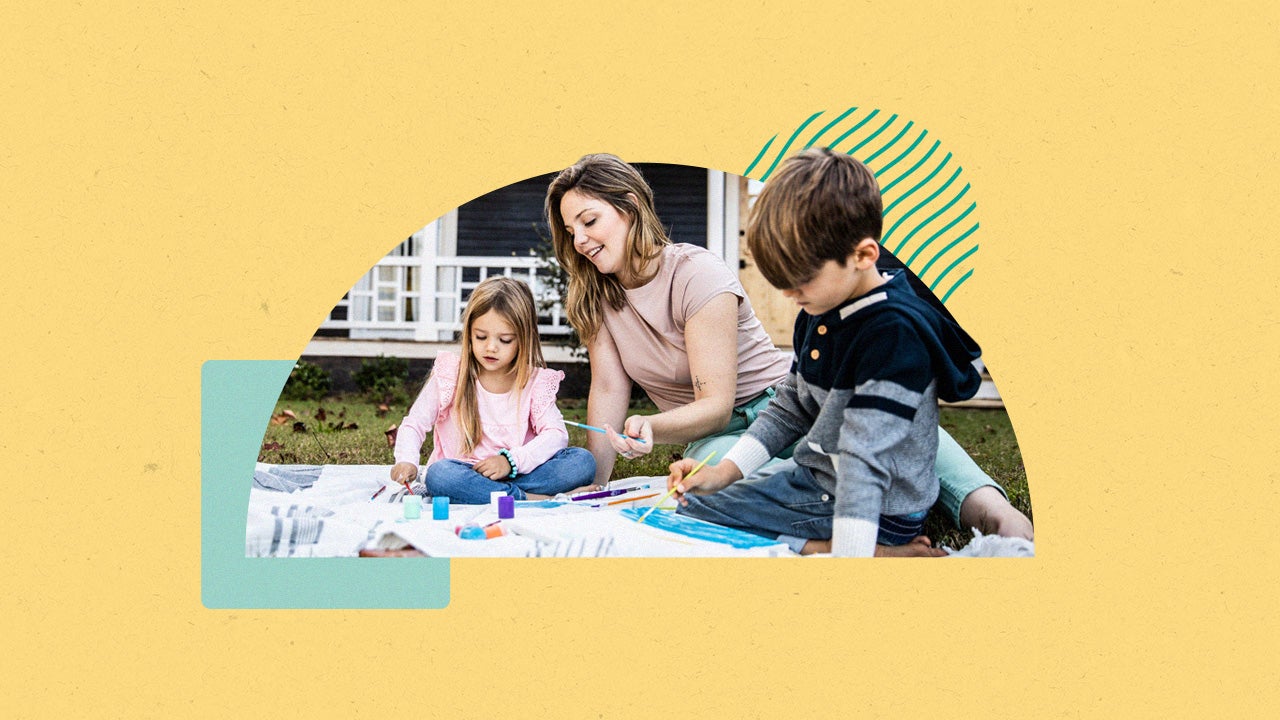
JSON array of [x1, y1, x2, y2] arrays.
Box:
[[453, 278, 547, 454]]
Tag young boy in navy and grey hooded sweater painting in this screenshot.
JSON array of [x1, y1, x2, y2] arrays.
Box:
[[668, 149, 980, 557]]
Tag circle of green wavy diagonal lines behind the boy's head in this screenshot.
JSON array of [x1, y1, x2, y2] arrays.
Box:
[[742, 108, 978, 304]]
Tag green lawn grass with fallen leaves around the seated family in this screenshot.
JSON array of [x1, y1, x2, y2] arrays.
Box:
[[257, 395, 1032, 547]]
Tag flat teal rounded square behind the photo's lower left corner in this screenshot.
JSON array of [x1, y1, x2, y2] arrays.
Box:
[[200, 360, 449, 609]]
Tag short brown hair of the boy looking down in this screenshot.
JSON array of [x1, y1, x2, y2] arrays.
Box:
[[746, 147, 883, 290]]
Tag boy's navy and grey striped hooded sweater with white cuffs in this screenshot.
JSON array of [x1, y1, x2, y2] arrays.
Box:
[[726, 273, 982, 550]]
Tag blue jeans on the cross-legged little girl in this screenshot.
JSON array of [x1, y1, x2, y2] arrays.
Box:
[[426, 447, 595, 505]]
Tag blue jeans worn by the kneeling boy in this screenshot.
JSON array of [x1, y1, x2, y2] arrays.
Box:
[[677, 460, 925, 552]]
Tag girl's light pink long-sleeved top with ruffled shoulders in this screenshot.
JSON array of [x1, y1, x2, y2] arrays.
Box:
[[396, 352, 568, 474]]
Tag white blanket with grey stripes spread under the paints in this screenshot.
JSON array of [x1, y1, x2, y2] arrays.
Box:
[[246, 462, 794, 557]]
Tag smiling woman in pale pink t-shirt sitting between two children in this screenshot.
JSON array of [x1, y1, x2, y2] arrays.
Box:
[[545, 155, 1032, 553]]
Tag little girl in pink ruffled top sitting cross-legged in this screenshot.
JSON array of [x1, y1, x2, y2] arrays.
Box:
[[392, 271, 595, 505]]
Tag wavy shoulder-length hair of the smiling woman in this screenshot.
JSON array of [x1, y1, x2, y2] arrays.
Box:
[[545, 154, 671, 343]]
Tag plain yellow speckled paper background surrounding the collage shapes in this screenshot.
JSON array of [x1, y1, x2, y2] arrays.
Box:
[[0, 1, 1280, 717]]
